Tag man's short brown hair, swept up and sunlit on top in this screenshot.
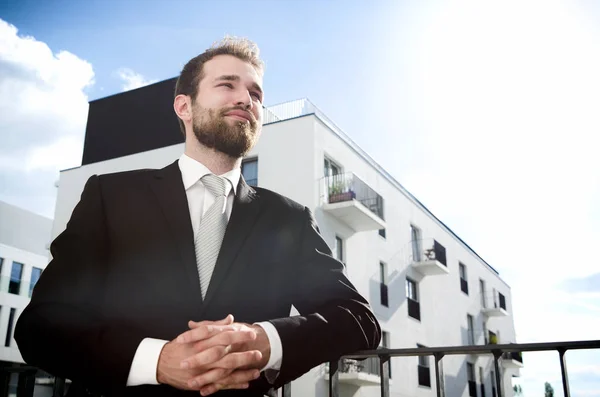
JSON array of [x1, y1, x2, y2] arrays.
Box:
[[175, 36, 265, 137]]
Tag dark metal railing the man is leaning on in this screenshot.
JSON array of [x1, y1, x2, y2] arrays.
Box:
[[0, 340, 600, 397]]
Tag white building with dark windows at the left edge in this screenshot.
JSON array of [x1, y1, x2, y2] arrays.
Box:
[[0, 201, 52, 363]]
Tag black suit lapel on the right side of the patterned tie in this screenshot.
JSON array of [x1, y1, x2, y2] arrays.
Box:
[[204, 177, 260, 308]]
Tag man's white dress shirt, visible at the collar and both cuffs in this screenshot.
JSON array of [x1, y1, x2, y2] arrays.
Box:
[[127, 154, 283, 386]]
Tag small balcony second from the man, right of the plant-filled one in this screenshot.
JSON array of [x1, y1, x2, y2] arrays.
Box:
[[407, 239, 450, 276]]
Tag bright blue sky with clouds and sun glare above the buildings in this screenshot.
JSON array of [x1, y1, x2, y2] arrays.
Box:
[[0, 0, 600, 396]]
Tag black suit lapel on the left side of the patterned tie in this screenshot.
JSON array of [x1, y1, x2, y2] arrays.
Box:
[[150, 161, 202, 306]]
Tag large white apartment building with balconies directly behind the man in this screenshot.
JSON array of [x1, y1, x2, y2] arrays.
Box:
[[51, 99, 521, 397]]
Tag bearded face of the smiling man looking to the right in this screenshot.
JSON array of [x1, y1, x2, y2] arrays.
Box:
[[192, 55, 263, 158]]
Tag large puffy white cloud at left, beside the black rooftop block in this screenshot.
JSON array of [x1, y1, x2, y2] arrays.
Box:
[[0, 20, 94, 216]]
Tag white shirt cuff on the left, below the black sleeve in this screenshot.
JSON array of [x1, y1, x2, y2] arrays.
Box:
[[127, 338, 169, 386]]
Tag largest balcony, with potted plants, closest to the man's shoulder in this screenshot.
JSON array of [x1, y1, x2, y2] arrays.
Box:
[[323, 173, 386, 232]]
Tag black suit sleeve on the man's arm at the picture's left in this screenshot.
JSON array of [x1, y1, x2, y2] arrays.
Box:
[[15, 175, 143, 391]]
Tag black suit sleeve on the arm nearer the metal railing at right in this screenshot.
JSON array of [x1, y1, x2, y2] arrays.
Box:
[[271, 208, 381, 387]]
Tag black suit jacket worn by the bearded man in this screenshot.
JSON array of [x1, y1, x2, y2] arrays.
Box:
[[15, 162, 380, 396]]
